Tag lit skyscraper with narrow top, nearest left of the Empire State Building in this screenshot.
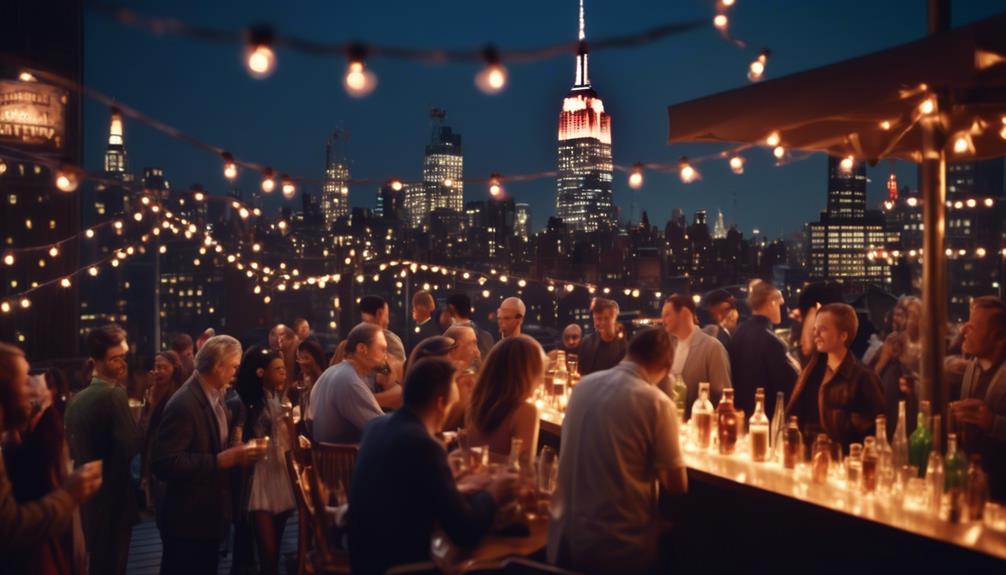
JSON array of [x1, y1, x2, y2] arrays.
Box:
[[405, 108, 465, 230]]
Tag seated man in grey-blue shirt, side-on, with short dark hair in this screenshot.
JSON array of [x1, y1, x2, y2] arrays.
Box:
[[311, 324, 387, 443]]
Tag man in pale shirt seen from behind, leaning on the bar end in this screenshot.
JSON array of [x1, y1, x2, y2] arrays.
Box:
[[548, 329, 688, 574]]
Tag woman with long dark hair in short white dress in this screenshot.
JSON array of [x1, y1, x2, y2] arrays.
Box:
[[236, 347, 296, 575]]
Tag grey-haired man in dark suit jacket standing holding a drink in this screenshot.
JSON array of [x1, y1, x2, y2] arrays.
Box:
[[151, 336, 266, 575]]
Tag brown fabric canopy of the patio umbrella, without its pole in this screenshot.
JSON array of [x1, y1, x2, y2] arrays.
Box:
[[668, 13, 1006, 163]]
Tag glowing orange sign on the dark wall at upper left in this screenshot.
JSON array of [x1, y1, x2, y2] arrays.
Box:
[[0, 80, 66, 151]]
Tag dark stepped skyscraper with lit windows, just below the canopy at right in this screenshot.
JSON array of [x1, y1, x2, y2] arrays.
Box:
[[809, 157, 890, 283]]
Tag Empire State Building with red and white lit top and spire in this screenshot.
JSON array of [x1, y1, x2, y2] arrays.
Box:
[[555, 0, 615, 232]]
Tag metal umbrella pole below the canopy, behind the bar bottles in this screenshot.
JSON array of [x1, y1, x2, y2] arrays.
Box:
[[918, 100, 947, 426]]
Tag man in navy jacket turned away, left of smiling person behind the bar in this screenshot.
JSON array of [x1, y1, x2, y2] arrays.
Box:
[[726, 279, 800, 417]]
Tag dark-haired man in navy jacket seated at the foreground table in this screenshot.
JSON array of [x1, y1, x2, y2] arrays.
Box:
[[349, 358, 516, 574]]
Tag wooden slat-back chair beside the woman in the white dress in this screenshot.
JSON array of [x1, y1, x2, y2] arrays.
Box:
[[287, 449, 350, 575]]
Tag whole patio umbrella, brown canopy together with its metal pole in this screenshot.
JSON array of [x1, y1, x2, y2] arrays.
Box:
[[668, 0, 1006, 413]]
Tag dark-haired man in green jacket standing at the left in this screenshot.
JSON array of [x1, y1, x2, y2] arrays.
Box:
[[65, 325, 142, 575]]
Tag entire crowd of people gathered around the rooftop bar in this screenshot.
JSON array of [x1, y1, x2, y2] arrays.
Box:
[[0, 280, 1006, 575]]
